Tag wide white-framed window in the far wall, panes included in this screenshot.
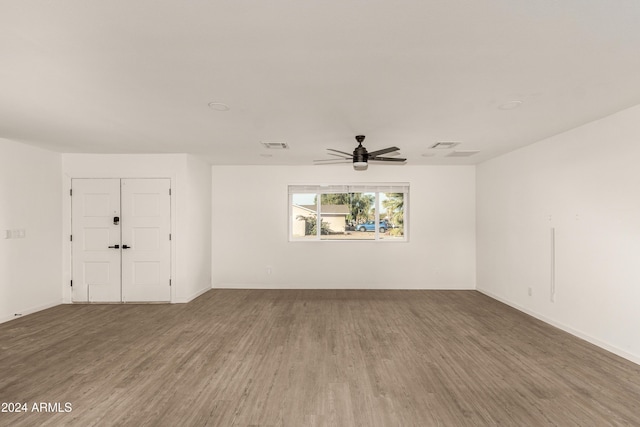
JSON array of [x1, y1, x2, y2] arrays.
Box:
[[289, 184, 409, 242]]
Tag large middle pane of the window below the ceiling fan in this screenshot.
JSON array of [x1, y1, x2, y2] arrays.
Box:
[[320, 193, 376, 240]]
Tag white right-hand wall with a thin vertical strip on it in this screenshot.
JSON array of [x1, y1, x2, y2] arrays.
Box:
[[477, 106, 640, 363]]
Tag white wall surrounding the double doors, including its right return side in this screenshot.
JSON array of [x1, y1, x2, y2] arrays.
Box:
[[62, 154, 211, 302]]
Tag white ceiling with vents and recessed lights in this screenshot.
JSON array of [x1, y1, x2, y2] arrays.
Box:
[[0, 0, 640, 167]]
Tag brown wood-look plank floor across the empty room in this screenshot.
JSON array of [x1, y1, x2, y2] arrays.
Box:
[[0, 290, 640, 427]]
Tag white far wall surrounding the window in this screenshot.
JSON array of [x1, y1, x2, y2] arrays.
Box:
[[212, 165, 475, 289]]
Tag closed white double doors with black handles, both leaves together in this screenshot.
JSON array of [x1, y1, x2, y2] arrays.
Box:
[[71, 179, 171, 302]]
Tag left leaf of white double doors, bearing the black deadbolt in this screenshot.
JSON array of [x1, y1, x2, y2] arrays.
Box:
[[71, 179, 121, 302]]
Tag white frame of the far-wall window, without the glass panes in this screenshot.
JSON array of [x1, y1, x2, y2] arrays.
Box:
[[287, 182, 410, 243]]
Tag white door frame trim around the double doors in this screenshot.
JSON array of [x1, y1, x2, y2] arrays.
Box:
[[62, 174, 176, 304]]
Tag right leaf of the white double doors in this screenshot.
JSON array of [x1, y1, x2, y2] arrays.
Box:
[[121, 179, 171, 302]]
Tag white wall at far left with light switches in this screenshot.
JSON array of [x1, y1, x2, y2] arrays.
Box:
[[0, 139, 62, 322]]
